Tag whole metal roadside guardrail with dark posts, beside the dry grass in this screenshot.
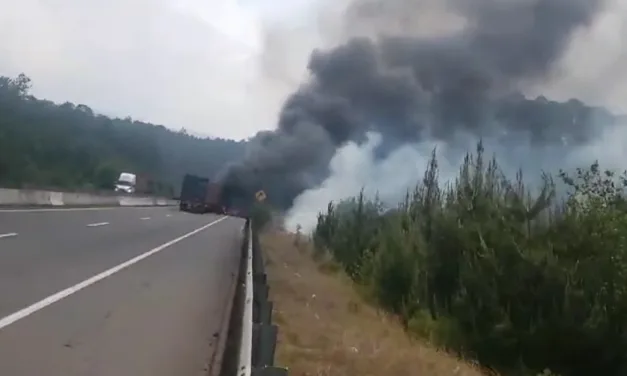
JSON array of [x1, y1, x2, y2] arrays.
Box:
[[237, 219, 287, 376]]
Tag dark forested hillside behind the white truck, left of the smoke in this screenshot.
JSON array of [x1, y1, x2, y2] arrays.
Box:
[[0, 75, 245, 193]]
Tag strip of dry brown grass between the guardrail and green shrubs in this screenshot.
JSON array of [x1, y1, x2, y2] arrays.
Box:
[[261, 232, 485, 376]]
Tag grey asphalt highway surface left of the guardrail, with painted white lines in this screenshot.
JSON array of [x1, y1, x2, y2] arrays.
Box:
[[0, 208, 244, 376]]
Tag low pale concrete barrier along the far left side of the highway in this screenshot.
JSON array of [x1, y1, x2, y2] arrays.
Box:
[[0, 188, 178, 207]]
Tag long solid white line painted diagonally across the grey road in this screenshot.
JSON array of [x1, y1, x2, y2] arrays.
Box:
[[0, 217, 228, 330]]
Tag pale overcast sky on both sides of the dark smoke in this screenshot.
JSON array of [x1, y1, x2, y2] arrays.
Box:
[[0, 0, 627, 138]]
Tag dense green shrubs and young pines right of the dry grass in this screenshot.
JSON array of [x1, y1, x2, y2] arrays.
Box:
[[313, 144, 627, 376]]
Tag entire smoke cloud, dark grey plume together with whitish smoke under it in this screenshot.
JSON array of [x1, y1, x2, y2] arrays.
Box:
[[220, 0, 615, 222]]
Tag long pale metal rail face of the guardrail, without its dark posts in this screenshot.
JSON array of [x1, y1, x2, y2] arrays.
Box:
[[237, 222, 253, 376]]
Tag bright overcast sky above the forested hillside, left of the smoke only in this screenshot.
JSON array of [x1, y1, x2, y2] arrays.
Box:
[[0, 0, 316, 138]]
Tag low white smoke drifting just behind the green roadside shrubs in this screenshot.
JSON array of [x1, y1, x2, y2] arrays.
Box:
[[285, 118, 627, 233]]
